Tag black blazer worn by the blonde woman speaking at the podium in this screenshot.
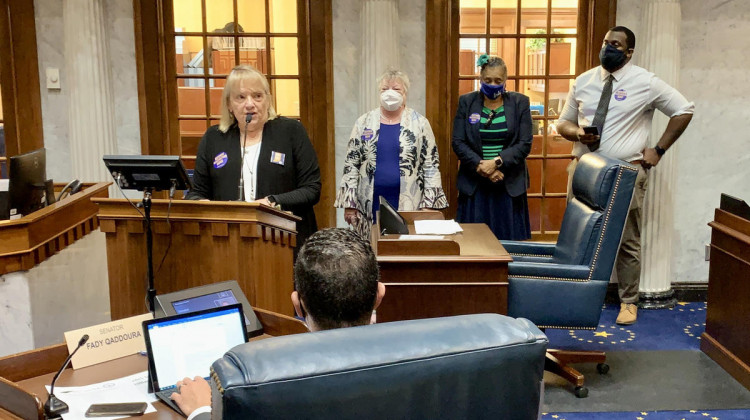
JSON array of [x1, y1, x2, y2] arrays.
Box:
[[186, 117, 320, 244]]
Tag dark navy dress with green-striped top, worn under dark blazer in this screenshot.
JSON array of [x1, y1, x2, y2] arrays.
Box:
[[456, 106, 531, 240]]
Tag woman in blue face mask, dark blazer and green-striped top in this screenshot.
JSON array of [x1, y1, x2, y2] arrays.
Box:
[[452, 54, 533, 240]]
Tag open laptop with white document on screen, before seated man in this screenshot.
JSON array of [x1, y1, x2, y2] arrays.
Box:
[[143, 304, 247, 416]]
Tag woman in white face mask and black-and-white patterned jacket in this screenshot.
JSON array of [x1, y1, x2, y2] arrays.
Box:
[[334, 70, 448, 238]]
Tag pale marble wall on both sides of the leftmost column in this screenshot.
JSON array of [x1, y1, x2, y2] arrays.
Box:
[[34, 0, 141, 182]]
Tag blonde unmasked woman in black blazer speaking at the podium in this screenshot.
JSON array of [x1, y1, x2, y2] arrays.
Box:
[[186, 65, 321, 250]]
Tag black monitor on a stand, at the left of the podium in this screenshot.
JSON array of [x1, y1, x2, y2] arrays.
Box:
[[102, 155, 190, 191]]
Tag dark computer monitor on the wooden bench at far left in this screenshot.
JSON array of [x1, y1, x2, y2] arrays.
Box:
[[3, 148, 47, 218]]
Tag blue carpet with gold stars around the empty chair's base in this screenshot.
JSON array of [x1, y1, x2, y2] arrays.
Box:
[[541, 302, 750, 420]]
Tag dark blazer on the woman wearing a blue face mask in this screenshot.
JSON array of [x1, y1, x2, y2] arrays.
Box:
[[451, 92, 533, 197]]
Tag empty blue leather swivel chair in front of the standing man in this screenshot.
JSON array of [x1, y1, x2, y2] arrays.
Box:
[[502, 153, 638, 398]]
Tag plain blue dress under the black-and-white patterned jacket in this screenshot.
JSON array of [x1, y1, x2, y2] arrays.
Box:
[[372, 124, 401, 221]]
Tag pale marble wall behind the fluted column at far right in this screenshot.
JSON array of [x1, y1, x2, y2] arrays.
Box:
[[617, 0, 750, 282]]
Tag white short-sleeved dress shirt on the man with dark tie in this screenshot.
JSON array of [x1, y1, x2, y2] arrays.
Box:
[[560, 63, 695, 162]]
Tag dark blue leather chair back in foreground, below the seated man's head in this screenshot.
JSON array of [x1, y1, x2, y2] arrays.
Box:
[[211, 314, 547, 420]]
